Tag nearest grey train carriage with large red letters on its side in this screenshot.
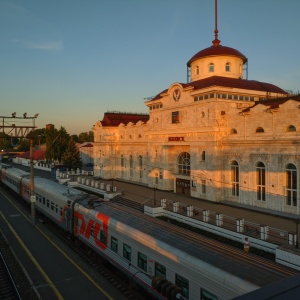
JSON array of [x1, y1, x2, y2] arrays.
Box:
[[74, 201, 259, 299]]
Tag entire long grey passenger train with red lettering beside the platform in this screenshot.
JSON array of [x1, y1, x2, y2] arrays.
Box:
[[0, 165, 292, 300]]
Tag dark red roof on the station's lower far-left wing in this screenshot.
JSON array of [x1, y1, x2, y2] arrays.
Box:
[[101, 112, 149, 126]]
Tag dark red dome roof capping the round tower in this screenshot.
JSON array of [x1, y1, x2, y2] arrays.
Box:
[[187, 45, 247, 67]]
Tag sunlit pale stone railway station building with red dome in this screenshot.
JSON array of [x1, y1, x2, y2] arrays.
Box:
[[93, 25, 300, 214]]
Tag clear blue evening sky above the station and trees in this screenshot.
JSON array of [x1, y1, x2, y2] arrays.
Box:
[[0, 0, 300, 134]]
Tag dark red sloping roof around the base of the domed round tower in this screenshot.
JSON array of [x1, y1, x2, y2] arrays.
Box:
[[152, 76, 287, 100]]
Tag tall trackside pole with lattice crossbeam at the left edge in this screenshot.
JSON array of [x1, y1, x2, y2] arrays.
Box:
[[0, 112, 39, 225]]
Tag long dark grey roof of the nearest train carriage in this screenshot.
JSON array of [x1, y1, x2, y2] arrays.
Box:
[[80, 201, 296, 286]]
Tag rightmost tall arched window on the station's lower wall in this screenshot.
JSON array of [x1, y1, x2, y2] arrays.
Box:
[[285, 164, 298, 206]]
